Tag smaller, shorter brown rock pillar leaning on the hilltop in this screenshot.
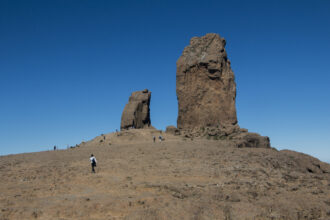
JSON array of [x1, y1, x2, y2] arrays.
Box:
[[120, 89, 151, 130]]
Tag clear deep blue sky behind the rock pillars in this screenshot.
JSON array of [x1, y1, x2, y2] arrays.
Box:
[[0, 0, 330, 162]]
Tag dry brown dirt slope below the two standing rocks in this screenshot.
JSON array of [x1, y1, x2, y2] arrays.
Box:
[[0, 129, 330, 220]]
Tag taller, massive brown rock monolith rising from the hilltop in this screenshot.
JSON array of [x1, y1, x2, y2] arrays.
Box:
[[176, 34, 237, 129]]
